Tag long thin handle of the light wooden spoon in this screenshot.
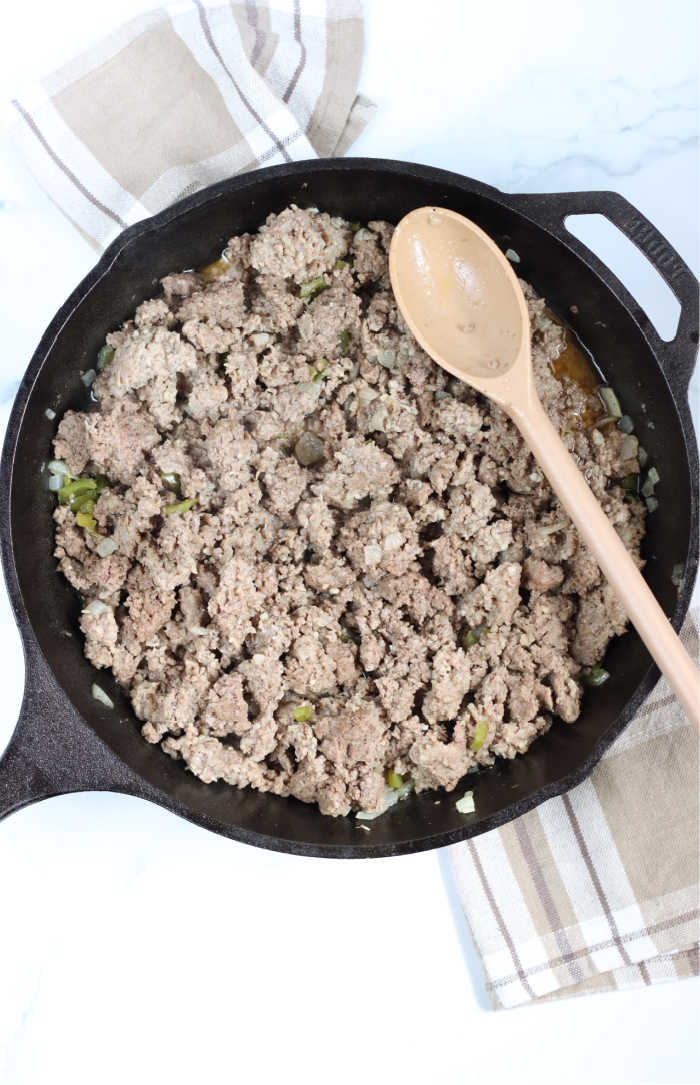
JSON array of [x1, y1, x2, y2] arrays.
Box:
[[511, 396, 700, 730]]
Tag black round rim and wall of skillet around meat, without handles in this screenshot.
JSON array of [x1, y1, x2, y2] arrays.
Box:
[[4, 159, 696, 856]]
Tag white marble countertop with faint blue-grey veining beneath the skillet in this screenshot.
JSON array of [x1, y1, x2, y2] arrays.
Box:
[[0, 0, 700, 1085]]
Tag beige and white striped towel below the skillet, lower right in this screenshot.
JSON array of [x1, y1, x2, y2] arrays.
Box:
[[449, 612, 700, 1008]]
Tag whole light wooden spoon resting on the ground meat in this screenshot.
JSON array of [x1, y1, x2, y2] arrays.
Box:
[[389, 207, 700, 729]]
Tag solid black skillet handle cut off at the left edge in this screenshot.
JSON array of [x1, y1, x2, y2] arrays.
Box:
[[0, 637, 148, 819]]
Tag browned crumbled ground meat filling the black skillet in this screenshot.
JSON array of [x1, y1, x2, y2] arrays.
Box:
[[55, 207, 644, 815]]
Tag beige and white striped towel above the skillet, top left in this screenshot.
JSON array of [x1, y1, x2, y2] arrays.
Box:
[[13, 0, 374, 246]]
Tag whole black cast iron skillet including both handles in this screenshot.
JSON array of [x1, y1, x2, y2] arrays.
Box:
[[0, 158, 698, 858]]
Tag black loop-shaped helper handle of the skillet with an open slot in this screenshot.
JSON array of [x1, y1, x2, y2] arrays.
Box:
[[512, 192, 700, 397]]
